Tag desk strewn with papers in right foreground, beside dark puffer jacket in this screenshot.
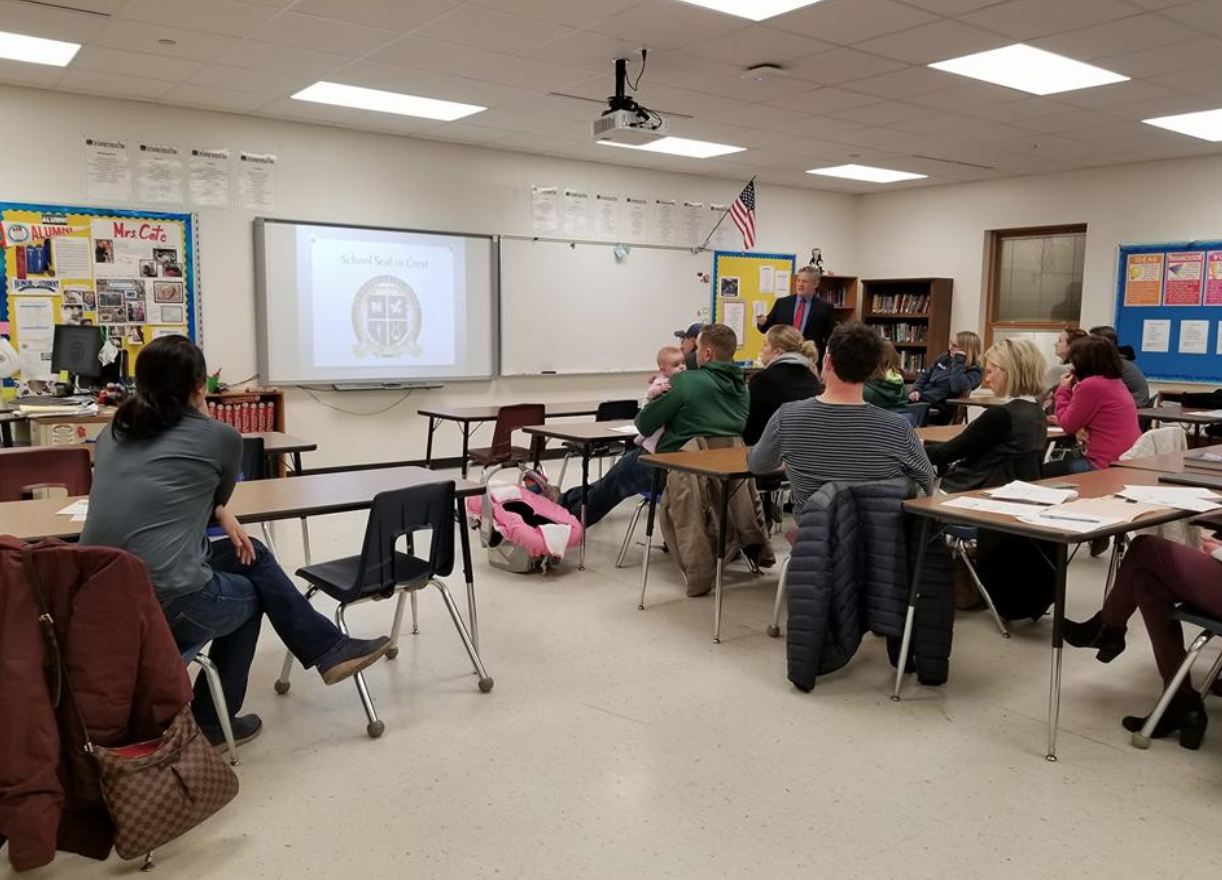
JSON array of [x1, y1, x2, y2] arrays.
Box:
[[891, 468, 1200, 761]]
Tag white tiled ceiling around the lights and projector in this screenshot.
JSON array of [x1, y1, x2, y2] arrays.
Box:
[[7, 0, 1222, 192]]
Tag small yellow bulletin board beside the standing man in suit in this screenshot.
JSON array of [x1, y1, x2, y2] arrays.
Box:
[[712, 251, 798, 363]]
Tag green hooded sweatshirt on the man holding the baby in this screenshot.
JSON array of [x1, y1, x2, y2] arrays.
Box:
[[637, 361, 750, 452]]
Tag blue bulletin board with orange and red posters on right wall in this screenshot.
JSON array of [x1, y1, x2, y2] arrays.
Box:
[[1116, 241, 1222, 383]]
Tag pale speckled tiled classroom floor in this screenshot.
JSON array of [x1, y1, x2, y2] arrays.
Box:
[[16, 481, 1222, 880]]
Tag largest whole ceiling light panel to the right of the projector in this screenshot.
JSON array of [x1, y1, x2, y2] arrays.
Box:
[[930, 43, 1128, 95]]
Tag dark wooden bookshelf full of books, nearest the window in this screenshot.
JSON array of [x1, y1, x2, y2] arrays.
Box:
[[862, 277, 954, 381]]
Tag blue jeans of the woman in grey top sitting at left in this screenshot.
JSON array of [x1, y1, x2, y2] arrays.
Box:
[[164, 539, 343, 727]]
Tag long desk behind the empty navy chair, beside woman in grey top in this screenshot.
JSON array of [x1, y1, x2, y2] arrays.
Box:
[[0, 467, 484, 644]]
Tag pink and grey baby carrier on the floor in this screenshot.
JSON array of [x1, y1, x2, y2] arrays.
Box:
[[467, 471, 582, 573]]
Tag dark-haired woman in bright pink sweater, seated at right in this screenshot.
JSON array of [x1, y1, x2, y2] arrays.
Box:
[[1046, 336, 1141, 477]]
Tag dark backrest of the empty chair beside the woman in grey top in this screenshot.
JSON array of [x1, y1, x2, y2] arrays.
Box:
[[348, 480, 455, 600]]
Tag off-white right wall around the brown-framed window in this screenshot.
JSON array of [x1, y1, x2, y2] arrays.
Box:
[[857, 156, 1222, 342]]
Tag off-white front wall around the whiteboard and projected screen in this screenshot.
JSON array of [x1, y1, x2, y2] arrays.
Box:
[[0, 87, 857, 467]]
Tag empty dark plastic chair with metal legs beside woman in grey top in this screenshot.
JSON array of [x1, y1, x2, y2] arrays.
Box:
[[276, 482, 492, 737]]
